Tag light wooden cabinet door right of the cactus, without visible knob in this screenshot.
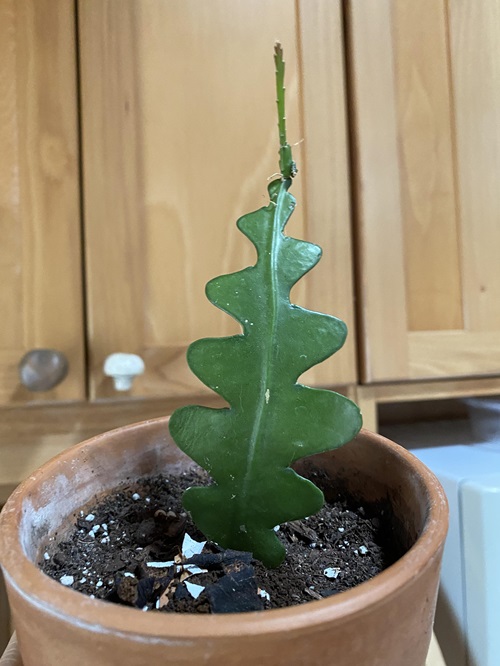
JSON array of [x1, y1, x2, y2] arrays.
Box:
[[348, 0, 500, 381]]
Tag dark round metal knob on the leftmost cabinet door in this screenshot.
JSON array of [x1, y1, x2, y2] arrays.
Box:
[[19, 349, 69, 391]]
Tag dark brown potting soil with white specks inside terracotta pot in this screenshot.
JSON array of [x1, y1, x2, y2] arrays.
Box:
[[40, 471, 404, 613]]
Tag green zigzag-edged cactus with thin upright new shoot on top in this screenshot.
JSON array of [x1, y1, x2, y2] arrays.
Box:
[[170, 45, 361, 567]]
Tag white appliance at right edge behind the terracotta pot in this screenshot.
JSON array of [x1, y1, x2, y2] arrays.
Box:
[[383, 421, 500, 666]]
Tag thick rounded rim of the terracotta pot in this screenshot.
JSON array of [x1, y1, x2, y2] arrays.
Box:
[[0, 417, 448, 644]]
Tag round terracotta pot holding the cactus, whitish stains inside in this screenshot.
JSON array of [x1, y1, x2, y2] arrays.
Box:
[[0, 418, 448, 666]]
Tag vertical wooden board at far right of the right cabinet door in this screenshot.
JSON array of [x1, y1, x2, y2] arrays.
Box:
[[449, 0, 500, 332]]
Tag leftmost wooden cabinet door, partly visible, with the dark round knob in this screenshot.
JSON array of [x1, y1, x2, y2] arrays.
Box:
[[0, 0, 85, 404]]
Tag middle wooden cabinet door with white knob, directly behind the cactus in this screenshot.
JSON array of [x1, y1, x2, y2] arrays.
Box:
[[79, 0, 356, 398]]
